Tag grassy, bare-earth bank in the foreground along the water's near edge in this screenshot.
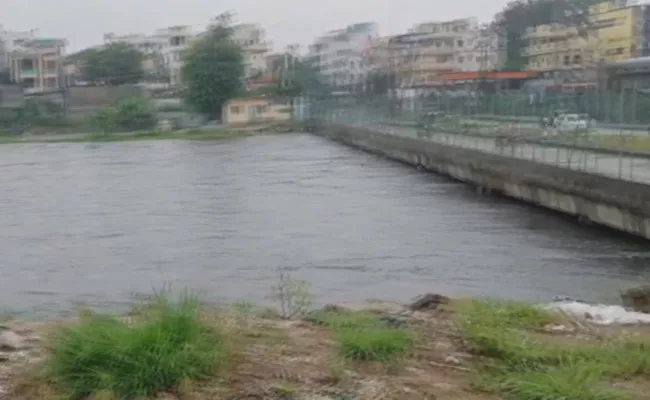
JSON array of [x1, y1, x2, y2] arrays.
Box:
[[0, 285, 650, 400]]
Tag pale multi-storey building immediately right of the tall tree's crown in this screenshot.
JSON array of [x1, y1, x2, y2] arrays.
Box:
[[233, 24, 272, 78]]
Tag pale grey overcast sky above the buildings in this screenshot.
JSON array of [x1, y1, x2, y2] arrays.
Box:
[[0, 0, 507, 51]]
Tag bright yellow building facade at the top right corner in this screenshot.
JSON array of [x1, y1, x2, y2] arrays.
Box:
[[590, 2, 639, 61]]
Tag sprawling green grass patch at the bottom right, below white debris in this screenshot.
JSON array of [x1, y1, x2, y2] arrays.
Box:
[[459, 301, 650, 400]]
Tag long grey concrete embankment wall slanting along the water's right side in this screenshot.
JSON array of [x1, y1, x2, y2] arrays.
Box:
[[307, 122, 650, 239]]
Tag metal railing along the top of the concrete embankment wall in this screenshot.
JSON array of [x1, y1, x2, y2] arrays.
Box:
[[311, 96, 650, 184]]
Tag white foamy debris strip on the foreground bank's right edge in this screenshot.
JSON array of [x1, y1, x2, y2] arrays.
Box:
[[545, 301, 650, 325]]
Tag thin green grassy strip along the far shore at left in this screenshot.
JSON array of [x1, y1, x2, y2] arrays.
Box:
[[0, 129, 255, 143]]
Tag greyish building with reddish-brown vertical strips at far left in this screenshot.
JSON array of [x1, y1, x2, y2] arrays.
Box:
[[10, 38, 67, 93]]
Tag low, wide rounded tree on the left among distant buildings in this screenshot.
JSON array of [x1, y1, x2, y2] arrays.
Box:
[[79, 43, 144, 86]]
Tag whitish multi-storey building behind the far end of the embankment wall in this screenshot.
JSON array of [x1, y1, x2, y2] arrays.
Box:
[[308, 22, 379, 90]]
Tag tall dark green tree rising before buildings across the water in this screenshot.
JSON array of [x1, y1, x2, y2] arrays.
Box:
[[182, 14, 244, 119]]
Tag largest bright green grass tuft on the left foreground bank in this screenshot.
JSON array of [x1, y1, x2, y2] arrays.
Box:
[[45, 295, 227, 399]]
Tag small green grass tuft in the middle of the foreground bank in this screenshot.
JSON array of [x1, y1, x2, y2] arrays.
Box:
[[311, 312, 413, 362]]
